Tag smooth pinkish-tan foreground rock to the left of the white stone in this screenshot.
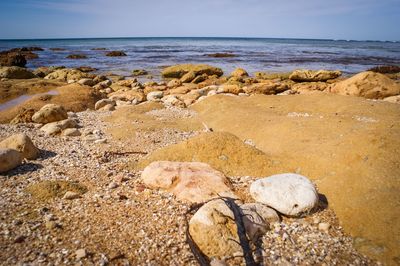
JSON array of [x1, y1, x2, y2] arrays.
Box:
[[141, 161, 235, 202]]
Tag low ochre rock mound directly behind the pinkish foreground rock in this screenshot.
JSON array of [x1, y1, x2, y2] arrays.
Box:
[[138, 132, 272, 176]]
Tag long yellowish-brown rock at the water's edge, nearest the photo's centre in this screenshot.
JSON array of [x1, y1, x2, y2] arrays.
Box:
[[162, 64, 223, 78]]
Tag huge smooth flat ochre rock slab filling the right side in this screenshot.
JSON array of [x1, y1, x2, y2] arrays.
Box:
[[191, 93, 400, 263]]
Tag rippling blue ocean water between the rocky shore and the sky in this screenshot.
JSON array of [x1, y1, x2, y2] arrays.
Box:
[[0, 38, 400, 76]]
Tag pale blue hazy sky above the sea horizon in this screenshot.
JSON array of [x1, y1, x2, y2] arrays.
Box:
[[0, 0, 400, 40]]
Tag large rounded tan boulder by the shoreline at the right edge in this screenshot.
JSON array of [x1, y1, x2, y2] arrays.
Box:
[[329, 72, 400, 99]]
